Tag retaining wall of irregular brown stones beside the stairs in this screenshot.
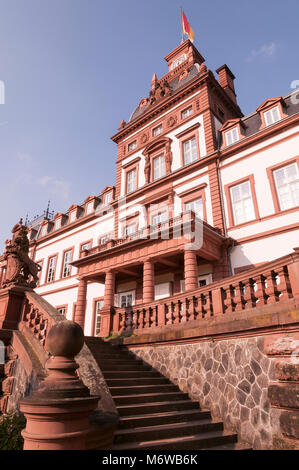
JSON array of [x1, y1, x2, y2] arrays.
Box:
[[132, 336, 279, 449]]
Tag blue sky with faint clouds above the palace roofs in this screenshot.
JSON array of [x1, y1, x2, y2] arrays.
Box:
[[0, 0, 299, 242]]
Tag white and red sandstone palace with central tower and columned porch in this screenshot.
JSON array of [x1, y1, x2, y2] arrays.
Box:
[[1, 40, 299, 336]]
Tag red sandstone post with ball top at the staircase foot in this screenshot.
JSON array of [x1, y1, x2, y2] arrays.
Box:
[[20, 320, 100, 450]]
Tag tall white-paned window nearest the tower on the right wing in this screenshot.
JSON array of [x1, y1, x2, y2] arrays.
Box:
[[230, 181, 255, 225]]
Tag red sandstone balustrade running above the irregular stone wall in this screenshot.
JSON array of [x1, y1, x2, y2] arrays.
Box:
[[112, 248, 299, 333]]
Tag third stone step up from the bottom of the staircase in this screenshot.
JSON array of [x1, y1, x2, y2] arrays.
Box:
[[118, 408, 211, 429]]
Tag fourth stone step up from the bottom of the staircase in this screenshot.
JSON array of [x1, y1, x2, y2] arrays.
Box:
[[117, 399, 199, 416]]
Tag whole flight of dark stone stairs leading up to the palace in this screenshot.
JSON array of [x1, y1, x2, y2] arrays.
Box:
[[88, 338, 247, 450]]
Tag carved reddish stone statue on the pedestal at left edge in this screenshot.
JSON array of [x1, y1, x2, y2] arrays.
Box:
[[2, 219, 41, 288]]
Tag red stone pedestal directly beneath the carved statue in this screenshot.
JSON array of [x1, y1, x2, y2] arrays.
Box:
[[0, 286, 31, 330]]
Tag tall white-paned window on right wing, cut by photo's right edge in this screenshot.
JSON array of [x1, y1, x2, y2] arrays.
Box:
[[273, 163, 299, 210]]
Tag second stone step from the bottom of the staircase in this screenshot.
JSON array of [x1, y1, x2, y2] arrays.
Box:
[[114, 419, 223, 444]]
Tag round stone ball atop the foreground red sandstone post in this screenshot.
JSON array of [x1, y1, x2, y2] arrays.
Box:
[[46, 320, 84, 358]]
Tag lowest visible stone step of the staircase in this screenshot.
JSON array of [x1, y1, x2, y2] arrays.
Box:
[[112, 431, 237, 451]]
